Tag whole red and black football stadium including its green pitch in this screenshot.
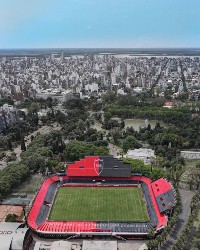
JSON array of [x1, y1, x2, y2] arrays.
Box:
[[27, 156, 176, 239]]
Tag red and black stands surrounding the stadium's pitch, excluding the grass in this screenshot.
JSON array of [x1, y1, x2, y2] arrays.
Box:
[[27, 156, 176, 239]]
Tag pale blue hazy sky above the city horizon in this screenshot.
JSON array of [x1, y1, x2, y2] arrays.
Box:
[[0, 0, 200, 49]]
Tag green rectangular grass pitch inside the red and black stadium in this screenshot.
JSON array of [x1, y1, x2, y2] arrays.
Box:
[[48, 187, 149, 221]]
